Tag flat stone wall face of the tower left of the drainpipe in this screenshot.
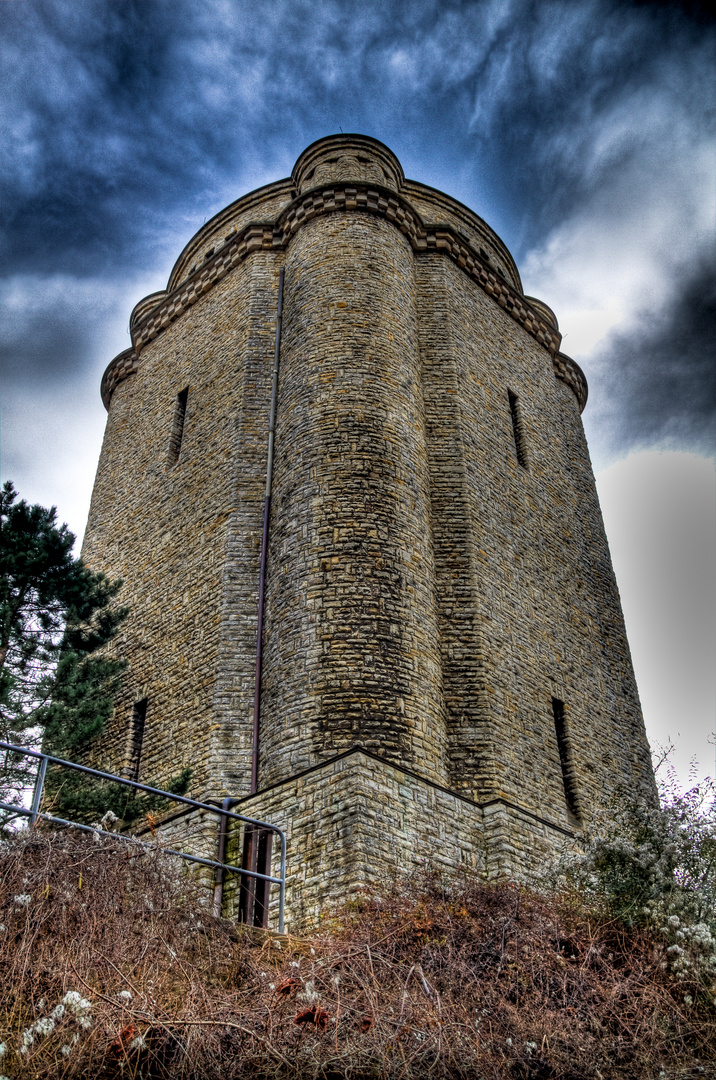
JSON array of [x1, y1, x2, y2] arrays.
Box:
[[83, 257, 273, 796]]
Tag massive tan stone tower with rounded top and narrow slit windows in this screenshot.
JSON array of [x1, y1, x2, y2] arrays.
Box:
[[83, 135, 653, 924]]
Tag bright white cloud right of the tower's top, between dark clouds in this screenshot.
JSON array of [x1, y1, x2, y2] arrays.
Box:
[[522, 91, 715, 356]]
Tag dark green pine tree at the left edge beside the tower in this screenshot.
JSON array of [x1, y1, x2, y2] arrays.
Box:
[[0, 483, 126, 821]]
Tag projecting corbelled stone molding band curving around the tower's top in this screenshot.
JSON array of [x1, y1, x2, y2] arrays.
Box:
[[102, 181, 586, 410]]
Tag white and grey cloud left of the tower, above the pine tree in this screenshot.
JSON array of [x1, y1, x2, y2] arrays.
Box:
[[0, 265, 165, 540]]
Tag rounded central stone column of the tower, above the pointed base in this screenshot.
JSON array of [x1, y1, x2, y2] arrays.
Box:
[[261, 213, 446, 786]]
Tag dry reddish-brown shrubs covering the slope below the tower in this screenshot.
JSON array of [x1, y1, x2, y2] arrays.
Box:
[[0, 832, 716, 1080]]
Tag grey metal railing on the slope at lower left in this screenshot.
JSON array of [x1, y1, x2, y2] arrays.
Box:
[[0, 741, 286, 934]]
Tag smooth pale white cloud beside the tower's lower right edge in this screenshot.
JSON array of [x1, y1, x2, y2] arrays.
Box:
[[597, 453, 716, 781]]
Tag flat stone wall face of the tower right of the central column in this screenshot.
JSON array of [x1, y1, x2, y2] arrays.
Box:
[[424, 260, 652, 824]]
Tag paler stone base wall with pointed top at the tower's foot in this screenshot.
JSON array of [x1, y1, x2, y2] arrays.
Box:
[[224, 750, 572, 932]]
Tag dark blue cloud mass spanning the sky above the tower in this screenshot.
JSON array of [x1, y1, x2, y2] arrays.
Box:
[[0, 0, 702, 273]]
